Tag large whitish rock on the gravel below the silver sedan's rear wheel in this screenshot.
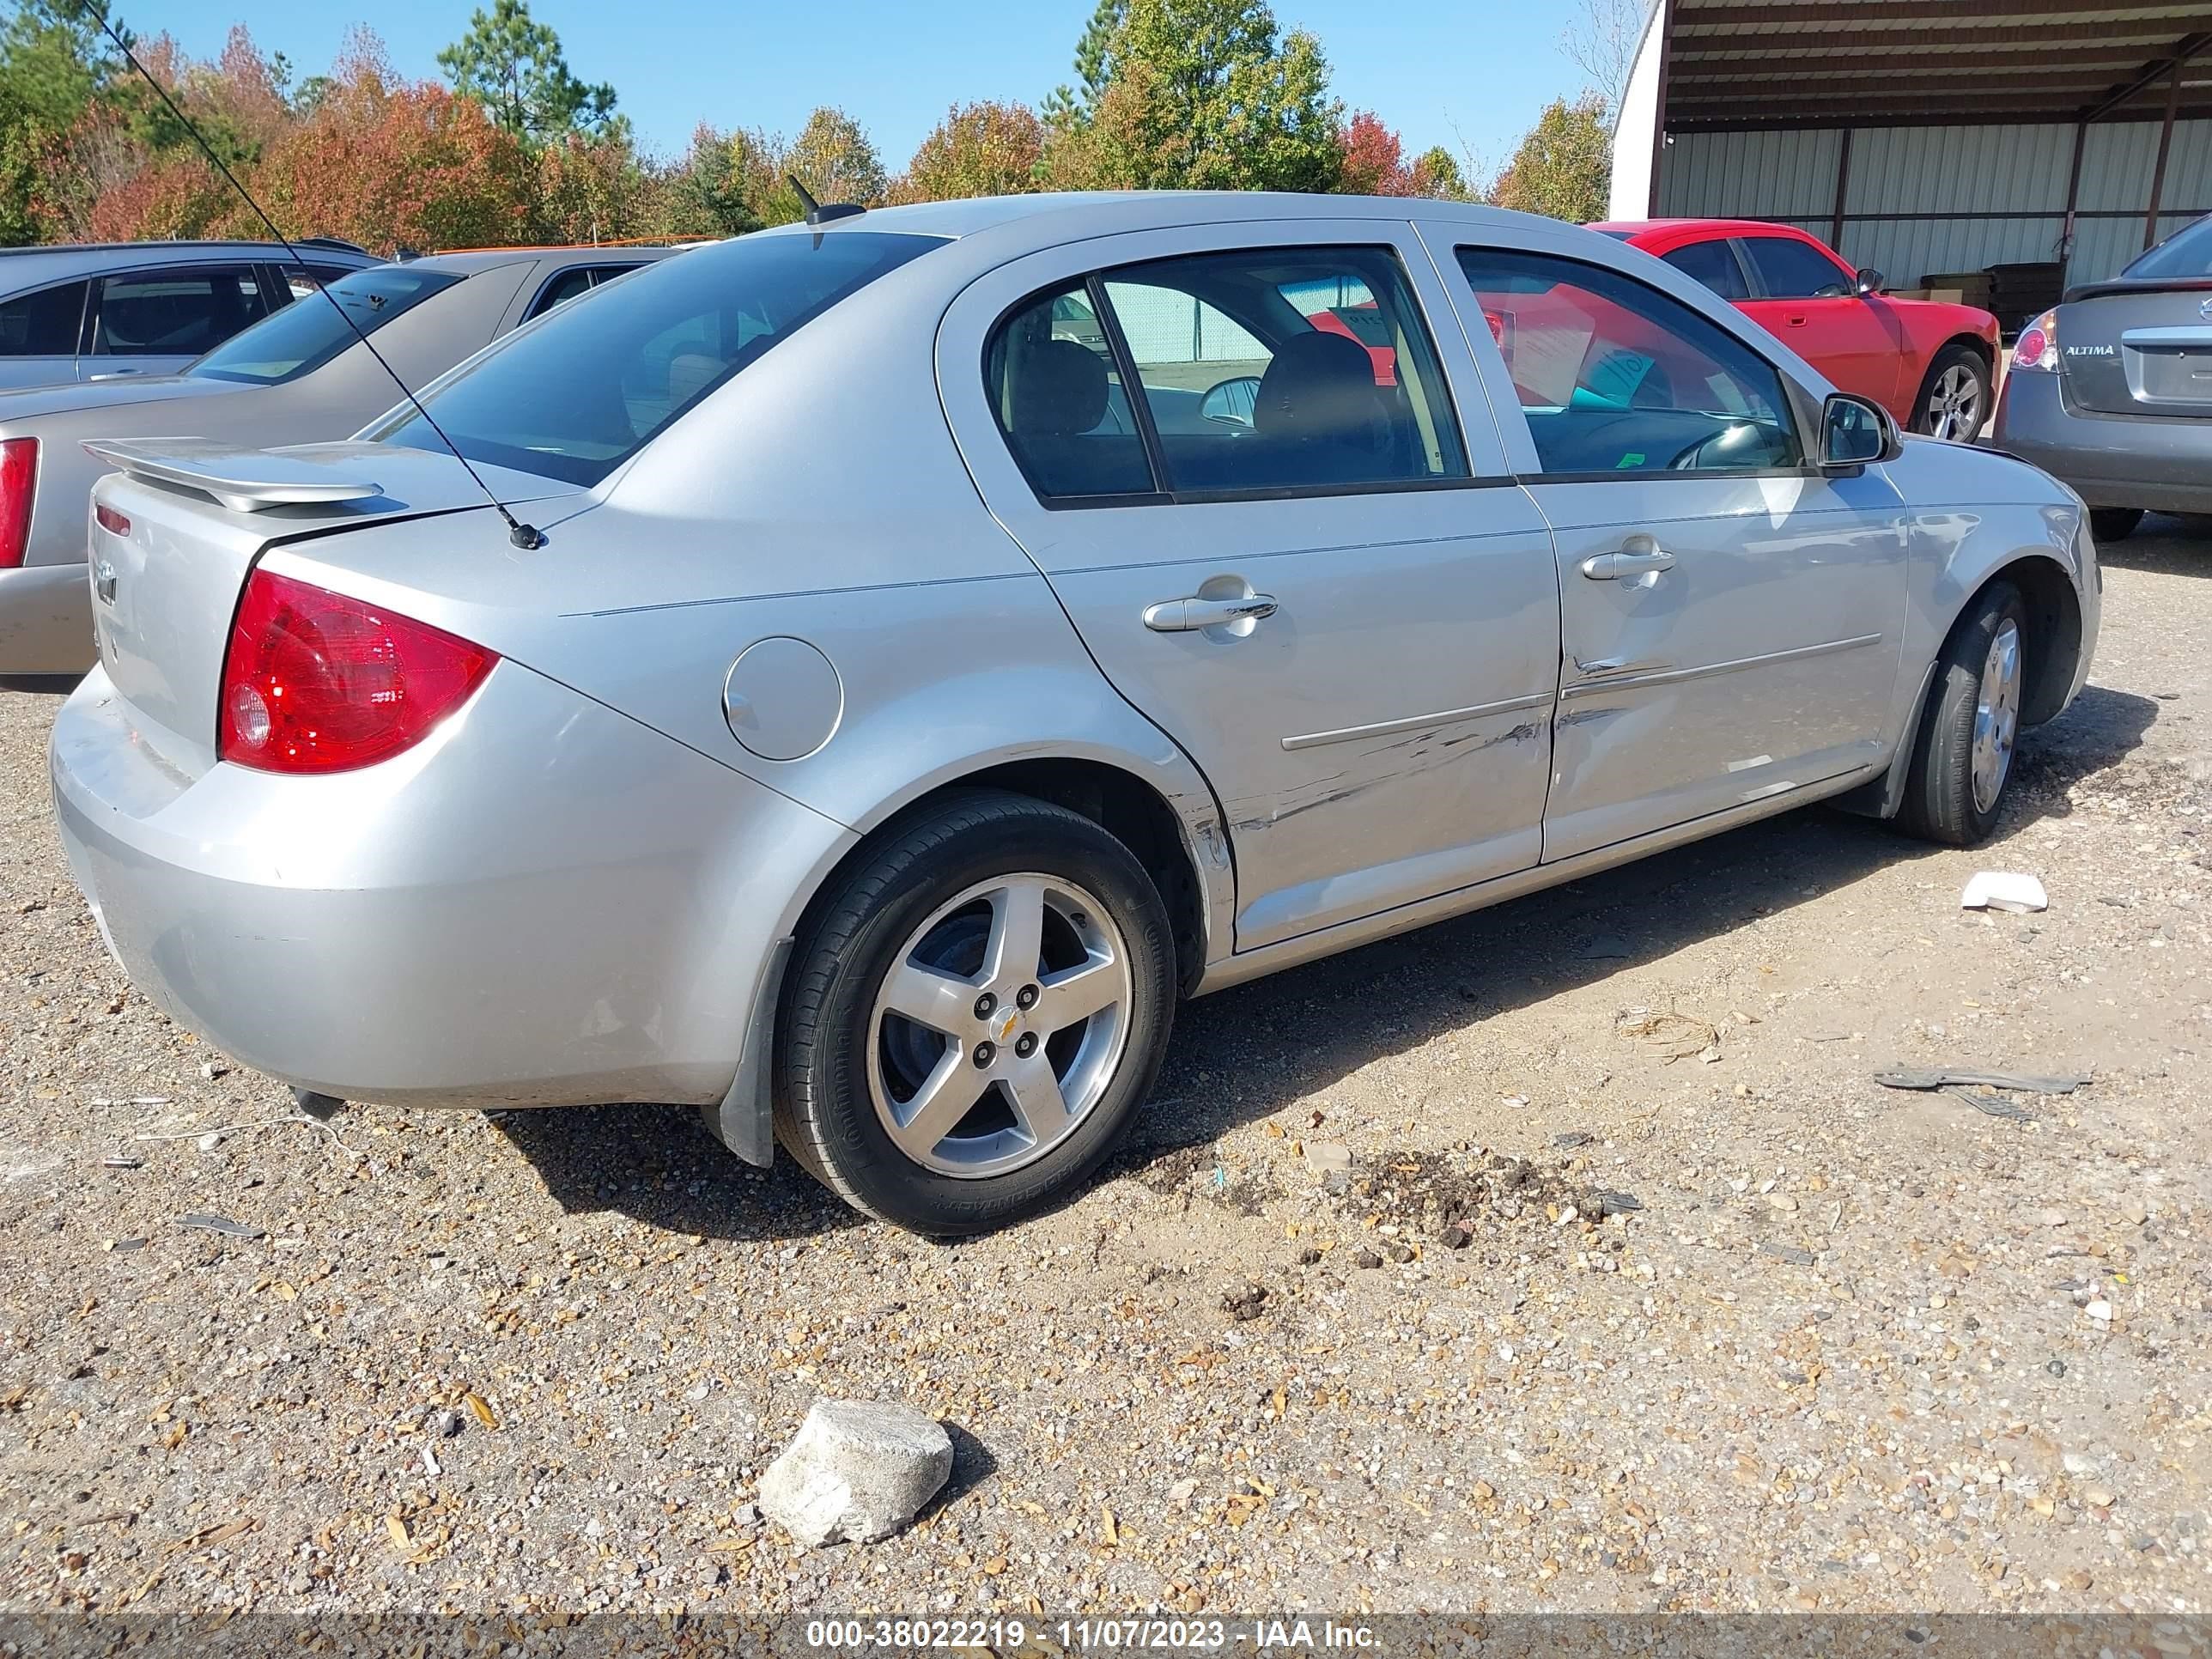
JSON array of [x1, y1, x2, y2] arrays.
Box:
[[761, 1401, 953, 1548]]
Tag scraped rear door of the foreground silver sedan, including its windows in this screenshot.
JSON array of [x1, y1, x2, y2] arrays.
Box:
[[938, 222, 1559, 949]]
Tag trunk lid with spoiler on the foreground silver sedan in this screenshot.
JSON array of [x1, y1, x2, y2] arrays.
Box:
[[86, 448, 573, 776]]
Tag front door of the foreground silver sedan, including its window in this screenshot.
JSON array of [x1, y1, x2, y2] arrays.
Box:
[[1451, 246, 1907, 860]]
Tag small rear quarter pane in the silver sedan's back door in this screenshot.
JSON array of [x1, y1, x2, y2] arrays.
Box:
[[984, 283, 1157, 500]]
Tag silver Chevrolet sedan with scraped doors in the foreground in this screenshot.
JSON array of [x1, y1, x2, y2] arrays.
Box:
[[51, 192, 2100, 1234]]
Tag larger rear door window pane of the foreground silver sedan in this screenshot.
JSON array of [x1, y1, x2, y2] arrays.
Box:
[[1103, 248, 1468, 495]]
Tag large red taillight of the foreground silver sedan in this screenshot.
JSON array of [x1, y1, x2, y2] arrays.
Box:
[[216, 571, 498, 772]]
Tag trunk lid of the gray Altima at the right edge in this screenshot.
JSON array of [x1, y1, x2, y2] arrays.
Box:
[[2059, 279, 2212, 420]]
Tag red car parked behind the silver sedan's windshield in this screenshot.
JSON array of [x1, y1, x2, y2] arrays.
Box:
[[1590, 219, 1997, 442]]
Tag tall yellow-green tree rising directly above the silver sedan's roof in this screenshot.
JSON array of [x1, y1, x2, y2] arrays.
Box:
[[1046, 0, 1343, 191]]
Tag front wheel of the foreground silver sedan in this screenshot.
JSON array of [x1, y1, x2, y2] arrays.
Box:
[[1898, 581, 2028, 848]]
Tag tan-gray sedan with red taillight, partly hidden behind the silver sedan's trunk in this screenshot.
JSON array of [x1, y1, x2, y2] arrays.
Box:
[[0, 248, 671, 677]]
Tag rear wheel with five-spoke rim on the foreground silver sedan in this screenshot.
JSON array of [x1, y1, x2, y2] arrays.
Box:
[[776, 792, 1175, 1237]]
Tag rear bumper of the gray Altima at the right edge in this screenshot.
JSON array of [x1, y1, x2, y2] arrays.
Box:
[[1990, 374, 2212, 514]]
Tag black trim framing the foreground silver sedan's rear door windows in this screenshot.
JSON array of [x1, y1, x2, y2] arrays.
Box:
[[980, 241, 1495, 514]]
